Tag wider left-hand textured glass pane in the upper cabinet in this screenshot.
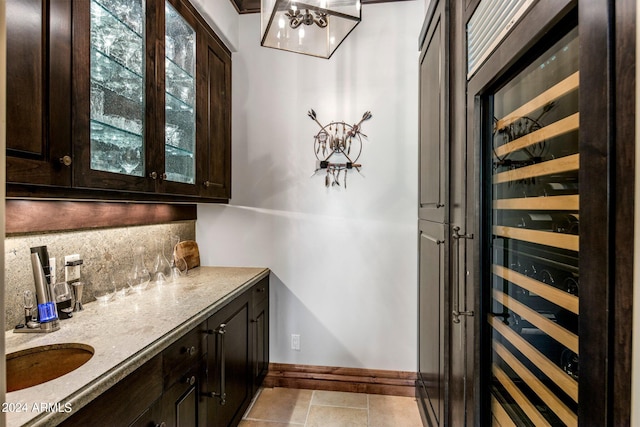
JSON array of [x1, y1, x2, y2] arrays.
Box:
[[90, 0, 145, 177]]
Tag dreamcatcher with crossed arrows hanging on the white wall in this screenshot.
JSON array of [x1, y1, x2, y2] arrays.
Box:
[[307, 110, 372, 188]]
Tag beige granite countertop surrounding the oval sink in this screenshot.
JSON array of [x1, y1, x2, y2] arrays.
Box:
[[2, 267, 269, 427]]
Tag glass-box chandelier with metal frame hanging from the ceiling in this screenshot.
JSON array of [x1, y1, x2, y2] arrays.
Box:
[[260, 0, 361, 58]]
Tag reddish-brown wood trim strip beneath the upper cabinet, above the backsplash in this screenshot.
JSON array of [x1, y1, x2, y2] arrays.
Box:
[[5, 199, 197, 235]]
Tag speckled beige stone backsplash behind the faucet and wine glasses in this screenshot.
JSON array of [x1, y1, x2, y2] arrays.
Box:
[[4, 221, 196, 330]]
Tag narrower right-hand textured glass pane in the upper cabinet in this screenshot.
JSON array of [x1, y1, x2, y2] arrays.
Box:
[[165, 2, 196, 184]]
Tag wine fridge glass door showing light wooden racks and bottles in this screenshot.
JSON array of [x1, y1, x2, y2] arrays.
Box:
[[490, 28, 580, 427]]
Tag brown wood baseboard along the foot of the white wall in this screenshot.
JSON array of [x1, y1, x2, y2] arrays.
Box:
[[263, 363, 417, 397]]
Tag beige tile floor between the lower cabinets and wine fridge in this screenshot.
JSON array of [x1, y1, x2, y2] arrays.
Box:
[[239, 387, 422, 427]]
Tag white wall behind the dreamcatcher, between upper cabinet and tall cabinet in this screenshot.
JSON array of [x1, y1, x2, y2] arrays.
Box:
[[196, 1, 424, 371]]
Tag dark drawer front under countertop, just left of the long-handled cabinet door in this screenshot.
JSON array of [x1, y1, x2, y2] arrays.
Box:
[[162, 326, 205, 389]]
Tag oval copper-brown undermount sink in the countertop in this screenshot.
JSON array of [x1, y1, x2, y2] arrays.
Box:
[[7, 343, 94, 392]]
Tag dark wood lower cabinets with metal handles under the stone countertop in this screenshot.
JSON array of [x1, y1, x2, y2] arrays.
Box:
[[61, 278, 269, 427]]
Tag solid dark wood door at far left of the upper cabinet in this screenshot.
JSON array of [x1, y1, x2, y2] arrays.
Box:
[[6, 0, 71, 186]]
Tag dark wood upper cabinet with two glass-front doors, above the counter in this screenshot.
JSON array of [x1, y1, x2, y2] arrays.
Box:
[[7, 0, 231, 202]]
